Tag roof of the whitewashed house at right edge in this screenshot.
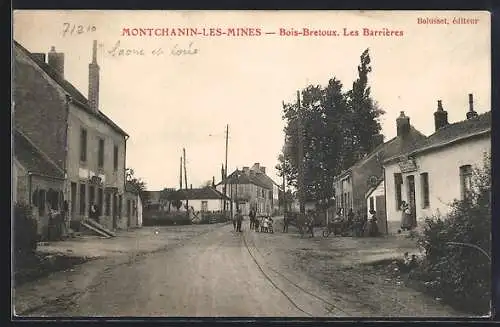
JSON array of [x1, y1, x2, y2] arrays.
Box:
[[411, 111, 491, 154]]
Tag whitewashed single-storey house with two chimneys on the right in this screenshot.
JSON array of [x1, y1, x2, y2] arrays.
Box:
[[384, 94, 491, 232]]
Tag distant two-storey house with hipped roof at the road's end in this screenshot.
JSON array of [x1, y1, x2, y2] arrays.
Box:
[[216, 162, 280, 215]]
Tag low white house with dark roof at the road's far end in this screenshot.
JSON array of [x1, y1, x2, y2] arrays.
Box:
[[174, 186, 231, 213]]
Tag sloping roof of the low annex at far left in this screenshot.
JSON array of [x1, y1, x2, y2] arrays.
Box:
[[14, 130, 64, 179]]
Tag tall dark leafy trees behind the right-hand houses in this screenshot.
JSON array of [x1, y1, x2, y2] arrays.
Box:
[[276, 49, 384, 204]]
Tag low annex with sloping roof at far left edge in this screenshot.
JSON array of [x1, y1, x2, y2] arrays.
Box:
[[12, 130, 65, 239]]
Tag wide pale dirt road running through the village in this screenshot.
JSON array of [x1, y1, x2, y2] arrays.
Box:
[[13, 225, 462, 317]]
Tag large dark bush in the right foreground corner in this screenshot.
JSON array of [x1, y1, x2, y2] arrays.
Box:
[[414, 158, 491, 314]]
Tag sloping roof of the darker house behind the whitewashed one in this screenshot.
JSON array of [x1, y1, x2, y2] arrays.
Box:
[[336, 125, 426, 179]]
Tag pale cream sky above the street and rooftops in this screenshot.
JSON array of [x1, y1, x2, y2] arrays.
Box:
[[13, 11, 491, 190]]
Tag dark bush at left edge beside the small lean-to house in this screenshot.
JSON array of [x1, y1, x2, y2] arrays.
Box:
[[13, 203, 38, 256]]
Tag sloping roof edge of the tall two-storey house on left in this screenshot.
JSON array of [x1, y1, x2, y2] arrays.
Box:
[[14, 40, 129, 136]]
